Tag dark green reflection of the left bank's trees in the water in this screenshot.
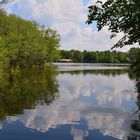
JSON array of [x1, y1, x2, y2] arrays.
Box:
[[0, 68, 58, 119]]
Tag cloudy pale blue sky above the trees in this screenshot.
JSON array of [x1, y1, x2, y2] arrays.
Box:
[[4, 0, 137, 51]]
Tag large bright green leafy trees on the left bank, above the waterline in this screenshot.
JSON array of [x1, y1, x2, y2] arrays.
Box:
[[0, 10, 60, 67]]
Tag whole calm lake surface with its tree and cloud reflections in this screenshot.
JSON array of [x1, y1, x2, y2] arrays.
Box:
[[0, 63, 140, 140]]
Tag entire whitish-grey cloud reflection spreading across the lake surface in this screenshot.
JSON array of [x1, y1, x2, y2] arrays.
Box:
[[5, 74, 136, 140]]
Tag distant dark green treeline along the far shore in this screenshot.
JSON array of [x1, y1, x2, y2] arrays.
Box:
[[60, 48, 140, 63]]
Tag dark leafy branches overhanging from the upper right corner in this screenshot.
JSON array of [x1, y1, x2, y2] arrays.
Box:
[[87, 0, 140, 48]]
